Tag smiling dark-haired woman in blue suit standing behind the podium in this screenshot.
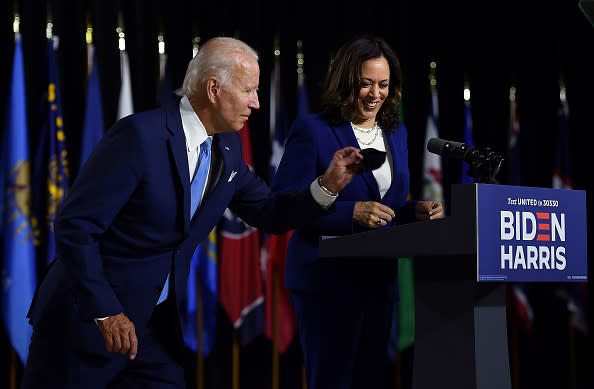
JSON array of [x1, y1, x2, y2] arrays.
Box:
[[272, 36, 443, 389]]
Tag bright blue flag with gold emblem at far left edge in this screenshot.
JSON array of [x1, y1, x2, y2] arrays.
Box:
[[0, 33, 36, 363]]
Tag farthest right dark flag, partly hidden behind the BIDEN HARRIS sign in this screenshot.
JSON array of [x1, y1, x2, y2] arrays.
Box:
[[552, 88, 589, 334]]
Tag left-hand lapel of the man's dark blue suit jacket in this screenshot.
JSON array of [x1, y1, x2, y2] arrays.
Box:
[[167, 100, 190, 235]]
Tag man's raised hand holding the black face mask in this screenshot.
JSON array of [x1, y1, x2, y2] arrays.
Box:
[[322, 146, 363, 193]]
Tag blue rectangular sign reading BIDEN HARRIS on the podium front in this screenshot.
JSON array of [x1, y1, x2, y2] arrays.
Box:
[[476, 184, 588, 282]]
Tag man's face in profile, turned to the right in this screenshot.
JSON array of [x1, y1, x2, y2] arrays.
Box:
[[215, 55, 260, 132]]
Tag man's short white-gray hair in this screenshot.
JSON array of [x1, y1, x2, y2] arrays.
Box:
[[175, 37, 258, 97]]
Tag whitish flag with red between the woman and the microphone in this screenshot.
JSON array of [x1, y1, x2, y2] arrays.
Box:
[[423, 86, 443, 201]]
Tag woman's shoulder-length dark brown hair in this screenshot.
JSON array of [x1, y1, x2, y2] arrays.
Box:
[[322, 35, 402, 132]]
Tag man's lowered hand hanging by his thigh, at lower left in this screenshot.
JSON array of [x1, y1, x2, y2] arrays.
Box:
[[97, 313, 138, 359]]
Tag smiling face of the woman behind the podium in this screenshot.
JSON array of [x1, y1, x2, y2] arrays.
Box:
[[353, 57, 390, 128]]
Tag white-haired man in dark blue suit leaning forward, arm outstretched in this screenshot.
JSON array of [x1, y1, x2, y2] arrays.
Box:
[[22, 38, 362, 388]]
